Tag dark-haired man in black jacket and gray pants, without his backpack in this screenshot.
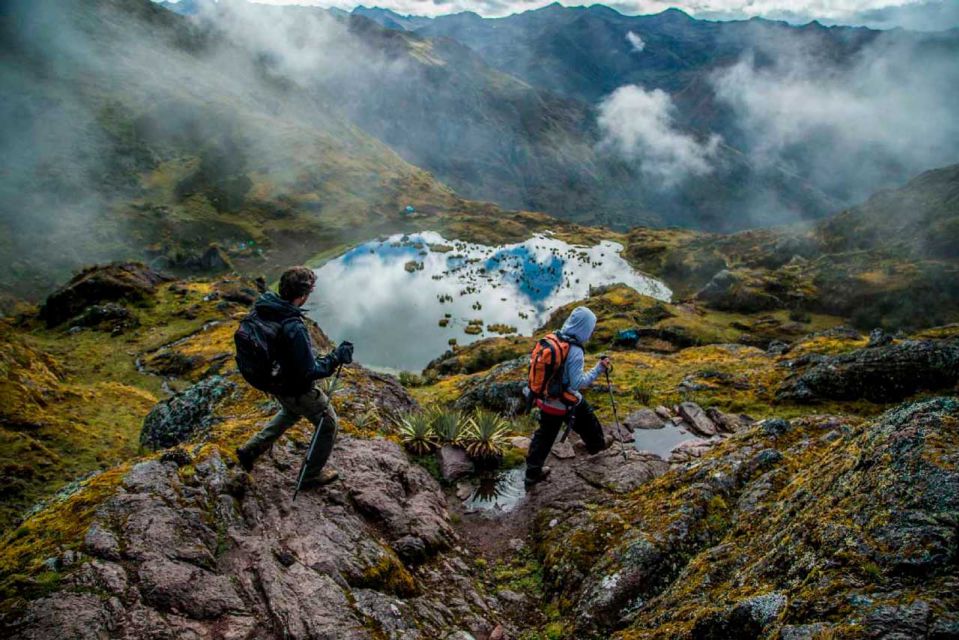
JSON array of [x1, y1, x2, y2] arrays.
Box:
[[236, 267, 353, 488]]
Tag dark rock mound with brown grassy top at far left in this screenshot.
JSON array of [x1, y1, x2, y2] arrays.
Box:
[[40, 262, 169, 327]]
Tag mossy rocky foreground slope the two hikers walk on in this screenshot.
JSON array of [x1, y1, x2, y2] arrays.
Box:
[[0, 248, 959, 639]]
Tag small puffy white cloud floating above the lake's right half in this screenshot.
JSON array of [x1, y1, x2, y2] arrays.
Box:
[[598, 85, 721, 187]]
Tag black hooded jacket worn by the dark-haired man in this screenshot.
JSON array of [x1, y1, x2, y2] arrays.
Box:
[[253, 291, 339, 396]]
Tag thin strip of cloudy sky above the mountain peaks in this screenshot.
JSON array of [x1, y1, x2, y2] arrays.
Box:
[[227, 0, 959, 30]]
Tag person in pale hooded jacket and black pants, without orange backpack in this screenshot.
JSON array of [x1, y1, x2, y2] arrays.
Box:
[[526, 307, 609, 486]]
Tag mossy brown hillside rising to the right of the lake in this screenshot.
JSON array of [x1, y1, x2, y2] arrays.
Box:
[[624, 165, 959, 330]]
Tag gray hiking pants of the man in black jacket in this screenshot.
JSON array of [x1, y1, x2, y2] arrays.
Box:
[[243, 387, 338, 479]]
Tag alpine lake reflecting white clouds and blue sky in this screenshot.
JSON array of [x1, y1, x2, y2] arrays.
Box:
[[307, 232, 671, 373]]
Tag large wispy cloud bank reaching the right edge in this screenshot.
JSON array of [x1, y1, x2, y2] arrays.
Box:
[[712, 34, 959, 201]]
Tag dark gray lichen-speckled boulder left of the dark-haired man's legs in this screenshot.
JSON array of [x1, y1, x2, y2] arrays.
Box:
[[140, 376, 236, 449]]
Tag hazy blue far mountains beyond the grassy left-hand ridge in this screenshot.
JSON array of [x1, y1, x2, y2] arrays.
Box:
[[154, 0, 959, 230]]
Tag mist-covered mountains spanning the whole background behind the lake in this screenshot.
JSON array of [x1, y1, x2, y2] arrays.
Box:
[[0, 0, 959, 296]]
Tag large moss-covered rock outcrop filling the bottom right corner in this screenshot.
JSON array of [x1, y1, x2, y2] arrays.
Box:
[[539, 398, 959, 639]]
